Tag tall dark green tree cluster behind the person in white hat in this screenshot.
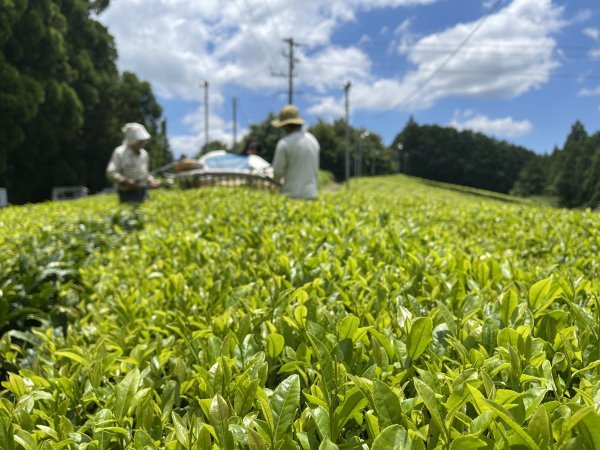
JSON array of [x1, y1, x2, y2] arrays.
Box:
[[0, 0, 172, 204]]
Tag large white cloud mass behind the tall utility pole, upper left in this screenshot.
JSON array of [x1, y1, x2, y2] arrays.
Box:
[[99, 0, 446, 100]]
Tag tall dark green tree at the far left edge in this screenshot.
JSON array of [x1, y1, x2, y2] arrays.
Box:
[[0, 0, 84, 203]]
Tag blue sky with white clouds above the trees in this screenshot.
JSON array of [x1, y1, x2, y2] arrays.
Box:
[[99, 0, 600, 156]]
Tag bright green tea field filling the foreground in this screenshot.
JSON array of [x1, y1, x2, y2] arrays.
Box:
[[0, 176, 600, 450]]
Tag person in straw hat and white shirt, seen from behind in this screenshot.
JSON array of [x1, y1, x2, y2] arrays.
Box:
[[271, 105, 320, 199]]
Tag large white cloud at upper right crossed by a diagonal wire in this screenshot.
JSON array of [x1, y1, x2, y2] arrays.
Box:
[[396, 0, 564, 105]]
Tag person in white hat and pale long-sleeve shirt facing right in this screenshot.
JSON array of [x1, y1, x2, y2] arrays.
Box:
[[106, 123, 160, 203]]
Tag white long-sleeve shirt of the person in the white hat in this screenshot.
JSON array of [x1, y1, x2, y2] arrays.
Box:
[[106, 144, 150, 189]]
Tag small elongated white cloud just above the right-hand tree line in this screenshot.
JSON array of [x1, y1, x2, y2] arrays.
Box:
[[448, 111, 533, 138]]
